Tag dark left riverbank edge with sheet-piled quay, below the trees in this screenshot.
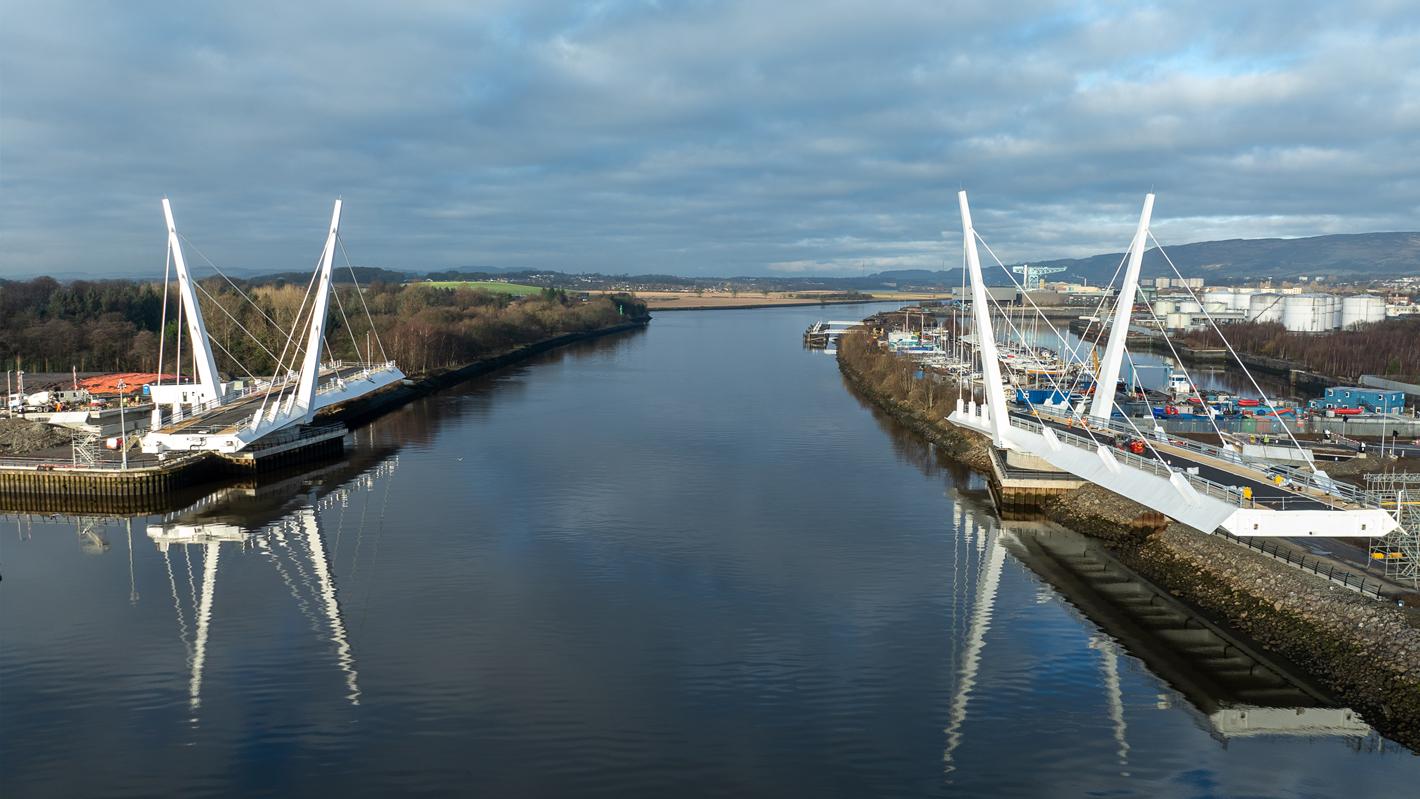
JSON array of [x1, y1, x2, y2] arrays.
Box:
[[0, 316, 650, 514]]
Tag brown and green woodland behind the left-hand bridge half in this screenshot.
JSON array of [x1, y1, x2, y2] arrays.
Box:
[[0, 277, 646, 378]]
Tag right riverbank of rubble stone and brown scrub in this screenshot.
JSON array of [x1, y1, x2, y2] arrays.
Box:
[[838, 345, 1420, 751]]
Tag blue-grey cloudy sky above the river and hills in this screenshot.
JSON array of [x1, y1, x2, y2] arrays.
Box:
[[0, 0, 1420, 277]]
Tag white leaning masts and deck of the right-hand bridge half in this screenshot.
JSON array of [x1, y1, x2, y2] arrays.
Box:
[[947, 192, 1399, 538]]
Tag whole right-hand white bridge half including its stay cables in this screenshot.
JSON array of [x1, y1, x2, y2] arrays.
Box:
[[947, 192, 1397, 538]]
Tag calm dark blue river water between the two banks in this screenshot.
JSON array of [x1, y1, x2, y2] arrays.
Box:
[[0, 308, 1420, 799]]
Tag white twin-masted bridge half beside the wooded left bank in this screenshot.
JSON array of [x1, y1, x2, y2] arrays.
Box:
[[142, 197, 405, 456]]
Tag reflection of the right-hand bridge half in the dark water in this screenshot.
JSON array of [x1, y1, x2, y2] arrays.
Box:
[[943, 492, 1373, 775]]
